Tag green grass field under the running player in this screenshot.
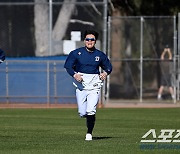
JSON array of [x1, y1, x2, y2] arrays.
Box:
[[0, 108, 180, 154]]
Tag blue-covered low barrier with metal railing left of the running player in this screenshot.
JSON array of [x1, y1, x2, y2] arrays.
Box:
[[0, 60, 76, 104]]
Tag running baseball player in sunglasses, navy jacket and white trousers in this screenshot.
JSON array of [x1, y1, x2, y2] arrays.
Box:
[[64, 30, 112, 141]]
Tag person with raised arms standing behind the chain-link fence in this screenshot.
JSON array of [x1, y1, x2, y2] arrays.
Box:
[[157, 45, 175, 100]]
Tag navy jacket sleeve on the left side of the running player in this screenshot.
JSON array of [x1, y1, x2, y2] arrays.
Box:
[[64, 51, 76, 76]]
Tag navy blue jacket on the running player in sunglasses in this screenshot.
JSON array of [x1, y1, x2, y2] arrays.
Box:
[[64, 47, 112, 76]]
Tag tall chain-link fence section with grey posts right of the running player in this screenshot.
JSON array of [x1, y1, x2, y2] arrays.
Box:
[[107, 16, 177, 102]]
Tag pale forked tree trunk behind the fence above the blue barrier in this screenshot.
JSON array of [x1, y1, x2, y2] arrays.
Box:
[[34, 0, 76, 56]]
